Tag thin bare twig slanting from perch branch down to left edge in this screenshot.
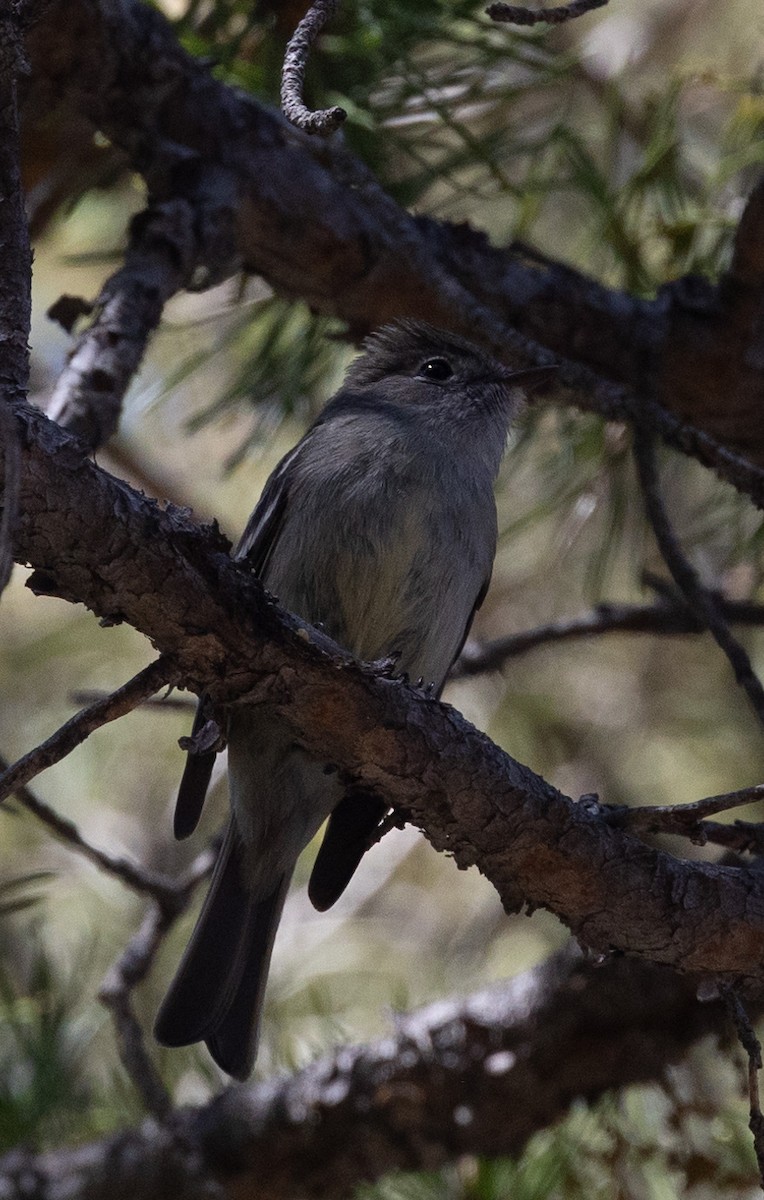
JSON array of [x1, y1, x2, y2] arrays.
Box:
[[0, 655, 176, 800]]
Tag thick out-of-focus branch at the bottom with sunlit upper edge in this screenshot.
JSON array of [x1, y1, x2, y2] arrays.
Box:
[[0, 952, 738, 1200]]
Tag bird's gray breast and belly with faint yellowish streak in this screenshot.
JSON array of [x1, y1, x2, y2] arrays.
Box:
[[264, 417, 497, 685]]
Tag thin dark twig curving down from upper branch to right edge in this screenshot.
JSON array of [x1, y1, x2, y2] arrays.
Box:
[[634, 421, 764, 725]]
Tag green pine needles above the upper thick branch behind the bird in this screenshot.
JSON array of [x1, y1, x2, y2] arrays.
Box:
[[171, 0, 764, 294]]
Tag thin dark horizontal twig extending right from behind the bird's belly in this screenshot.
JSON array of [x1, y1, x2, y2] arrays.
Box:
[[451, 596, 764, 679]]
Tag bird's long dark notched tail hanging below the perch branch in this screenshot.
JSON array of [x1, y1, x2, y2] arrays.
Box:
[[155, 823, 291, 1079]]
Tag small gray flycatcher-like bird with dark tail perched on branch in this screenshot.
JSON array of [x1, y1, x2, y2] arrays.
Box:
[[155, 319, 549, 1080]]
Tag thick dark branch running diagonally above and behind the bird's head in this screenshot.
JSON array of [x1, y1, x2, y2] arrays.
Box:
[[17, 0, 764, 477]]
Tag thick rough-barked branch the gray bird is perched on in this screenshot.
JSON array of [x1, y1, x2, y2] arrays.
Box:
[[7, 396, 764, 979]]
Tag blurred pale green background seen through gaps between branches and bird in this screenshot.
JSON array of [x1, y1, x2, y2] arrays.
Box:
[[0, 0, 764, 1200]]
